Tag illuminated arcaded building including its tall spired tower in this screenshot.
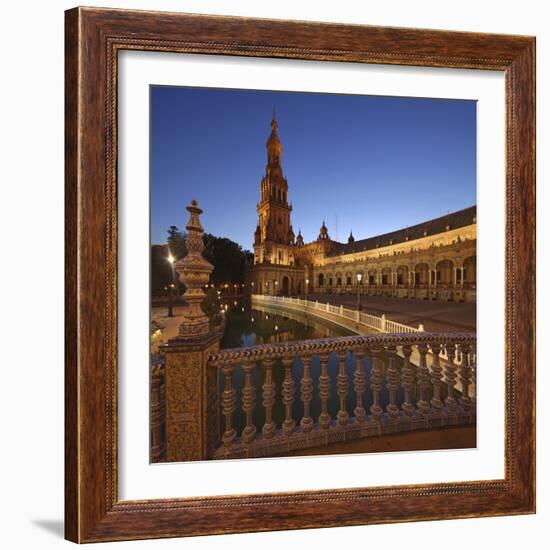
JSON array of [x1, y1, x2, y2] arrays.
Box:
[[246, 117, 477, 302]]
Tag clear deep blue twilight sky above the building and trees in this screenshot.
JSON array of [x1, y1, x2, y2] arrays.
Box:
[[151, 86, 476, 250]]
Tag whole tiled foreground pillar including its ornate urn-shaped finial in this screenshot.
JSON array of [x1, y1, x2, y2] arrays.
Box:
[[164, 201, 221, 462]]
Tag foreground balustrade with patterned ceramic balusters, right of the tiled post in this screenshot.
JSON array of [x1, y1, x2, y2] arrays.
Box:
[[208, 333, 476, 459]]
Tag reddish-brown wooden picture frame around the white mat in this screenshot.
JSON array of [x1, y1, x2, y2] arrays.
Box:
[[65, 8, 535, 542]]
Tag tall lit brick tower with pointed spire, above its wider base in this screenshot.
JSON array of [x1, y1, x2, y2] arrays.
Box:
[[254, 111, 294, 265]]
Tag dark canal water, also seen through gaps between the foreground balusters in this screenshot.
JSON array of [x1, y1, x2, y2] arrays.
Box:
[[220, 301, 410, 435]]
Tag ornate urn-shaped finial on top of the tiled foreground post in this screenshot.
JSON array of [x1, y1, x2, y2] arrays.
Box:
[[175, 200, 214, 338]]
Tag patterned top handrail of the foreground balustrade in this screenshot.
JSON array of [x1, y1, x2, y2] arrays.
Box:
[[208, 332, 476, 367]]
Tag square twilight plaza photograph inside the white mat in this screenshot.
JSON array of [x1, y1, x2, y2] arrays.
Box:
[[150, 86, 477, 462]]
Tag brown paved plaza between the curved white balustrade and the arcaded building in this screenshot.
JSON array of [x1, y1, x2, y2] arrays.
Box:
[[302, 294, 476, 332]]
